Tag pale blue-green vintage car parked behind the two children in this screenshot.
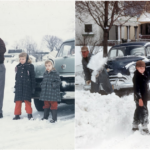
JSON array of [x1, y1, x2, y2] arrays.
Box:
[[32, 39, 75, 111]]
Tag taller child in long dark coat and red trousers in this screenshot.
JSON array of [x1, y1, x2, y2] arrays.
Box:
[[13, 53, 35, 120]]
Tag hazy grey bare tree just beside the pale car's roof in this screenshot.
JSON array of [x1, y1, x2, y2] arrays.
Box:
[[43, 35, 63, 51]]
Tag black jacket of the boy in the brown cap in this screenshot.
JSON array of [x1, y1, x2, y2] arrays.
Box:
[[133, 70, 150, 106]]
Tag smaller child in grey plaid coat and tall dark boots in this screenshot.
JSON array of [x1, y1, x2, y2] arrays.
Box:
[[40, 59, 61, 123]]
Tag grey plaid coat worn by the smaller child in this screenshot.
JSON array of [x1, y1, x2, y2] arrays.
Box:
[[40, 70, 61, 102]]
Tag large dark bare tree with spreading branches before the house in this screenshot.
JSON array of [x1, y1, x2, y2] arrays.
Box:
[[76, 1, 146, 57]]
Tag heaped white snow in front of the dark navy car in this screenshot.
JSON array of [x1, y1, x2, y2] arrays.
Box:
[[75, 90, 150, 149]]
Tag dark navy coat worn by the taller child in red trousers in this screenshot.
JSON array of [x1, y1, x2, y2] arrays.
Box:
[[15, 63, 35, 102]]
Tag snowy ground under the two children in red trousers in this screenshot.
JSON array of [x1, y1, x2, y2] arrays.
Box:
[[0, 63, 75, 149]]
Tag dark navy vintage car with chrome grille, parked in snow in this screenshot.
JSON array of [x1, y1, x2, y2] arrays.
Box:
[[106, 42, 150, 93]]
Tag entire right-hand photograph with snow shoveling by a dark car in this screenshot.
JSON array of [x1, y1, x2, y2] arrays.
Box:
[[75, 1, 150, 149]]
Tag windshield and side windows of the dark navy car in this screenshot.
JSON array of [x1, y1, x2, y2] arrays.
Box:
[[109, 46, 145, 58]]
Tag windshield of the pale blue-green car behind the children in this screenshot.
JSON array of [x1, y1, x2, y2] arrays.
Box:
[[57, 42, 75, 57]]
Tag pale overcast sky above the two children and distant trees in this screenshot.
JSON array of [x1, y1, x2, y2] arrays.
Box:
[[0, 1, 75, 49]]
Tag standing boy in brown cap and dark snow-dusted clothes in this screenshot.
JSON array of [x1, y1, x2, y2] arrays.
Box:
[[132, 60, 149, 133]]
